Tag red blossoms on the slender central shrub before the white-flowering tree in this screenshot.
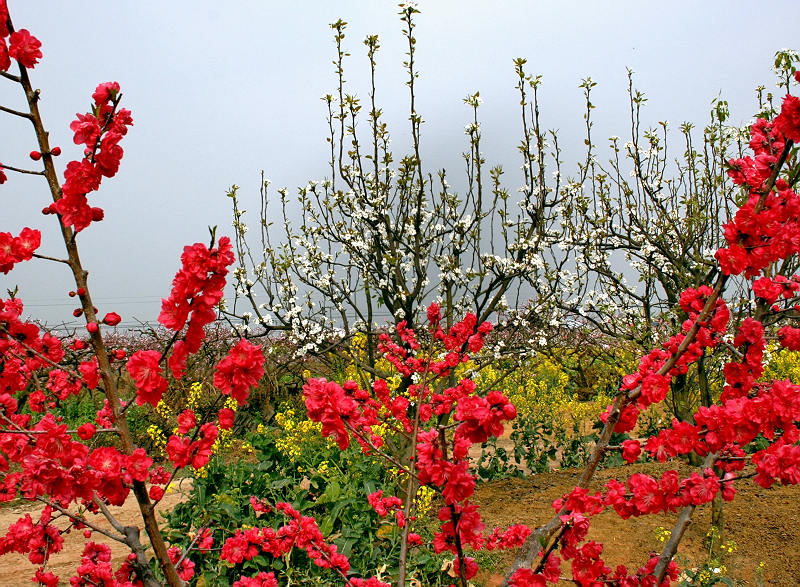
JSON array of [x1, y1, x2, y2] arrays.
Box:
[[303, 304, 530, 585]]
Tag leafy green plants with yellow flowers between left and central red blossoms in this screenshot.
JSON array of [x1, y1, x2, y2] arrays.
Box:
[[166, 410, 450, 586]]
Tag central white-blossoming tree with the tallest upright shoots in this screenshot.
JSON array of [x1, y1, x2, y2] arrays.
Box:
[[222, 5, 560, 386]]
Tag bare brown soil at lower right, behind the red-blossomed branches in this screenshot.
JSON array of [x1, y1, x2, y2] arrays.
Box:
[[475, 463, 800, 587]]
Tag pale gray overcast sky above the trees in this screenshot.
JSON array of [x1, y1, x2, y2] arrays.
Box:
[[0, 0, 800, 324]]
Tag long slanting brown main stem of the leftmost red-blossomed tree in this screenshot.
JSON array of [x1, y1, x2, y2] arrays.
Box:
[[8, 12, 184, 587]]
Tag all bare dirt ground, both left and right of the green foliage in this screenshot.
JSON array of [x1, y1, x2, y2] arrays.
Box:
[[0, 464, 800, 587]]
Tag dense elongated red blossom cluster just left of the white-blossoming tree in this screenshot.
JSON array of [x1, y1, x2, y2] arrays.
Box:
[[158, 236, 234, 378]]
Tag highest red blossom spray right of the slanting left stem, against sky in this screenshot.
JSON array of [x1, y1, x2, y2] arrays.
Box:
[[44, 82, 133, 232]]
